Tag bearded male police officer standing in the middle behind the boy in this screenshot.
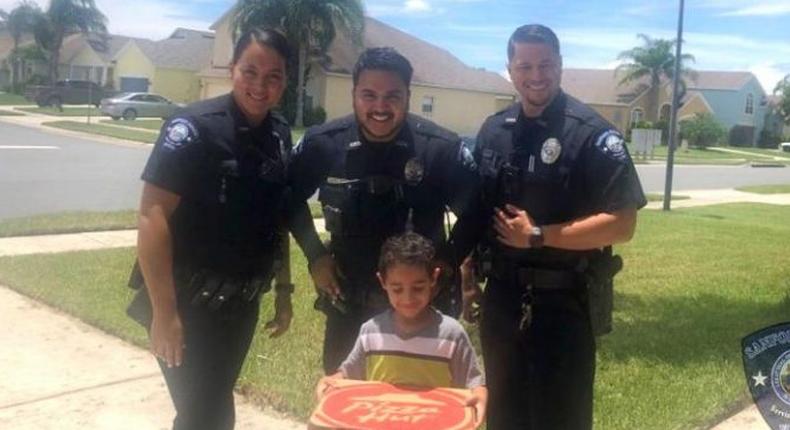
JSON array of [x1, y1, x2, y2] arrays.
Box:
[[290, 48, 478, 374]]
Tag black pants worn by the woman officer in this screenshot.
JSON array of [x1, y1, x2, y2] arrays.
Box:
[[159, 300, 259, 430]]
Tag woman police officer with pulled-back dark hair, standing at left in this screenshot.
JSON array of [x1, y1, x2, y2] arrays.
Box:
[[131, 29, 291, 430]]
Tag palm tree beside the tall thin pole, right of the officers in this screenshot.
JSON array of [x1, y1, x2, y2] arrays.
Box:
[[615, 34, 694, 121]]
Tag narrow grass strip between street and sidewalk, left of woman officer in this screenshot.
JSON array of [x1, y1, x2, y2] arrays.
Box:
[[0, 210, 137, 237]]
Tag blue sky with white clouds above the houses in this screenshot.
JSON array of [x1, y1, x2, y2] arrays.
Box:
[[0, 0, 790, 93]]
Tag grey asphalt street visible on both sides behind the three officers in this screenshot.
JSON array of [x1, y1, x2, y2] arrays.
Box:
[[0, 122, 790, 219]]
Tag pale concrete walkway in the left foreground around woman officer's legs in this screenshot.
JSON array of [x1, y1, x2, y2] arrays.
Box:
[[0, 287, 305, 430]]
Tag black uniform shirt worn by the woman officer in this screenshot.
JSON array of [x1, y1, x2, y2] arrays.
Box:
[[142, 94, 291, 276]]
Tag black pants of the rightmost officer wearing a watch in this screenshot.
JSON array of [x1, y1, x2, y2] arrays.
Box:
[[481, 280, 595, 430]]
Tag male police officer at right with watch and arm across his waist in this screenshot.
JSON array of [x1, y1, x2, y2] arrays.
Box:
[[464, 25, 646, 430]]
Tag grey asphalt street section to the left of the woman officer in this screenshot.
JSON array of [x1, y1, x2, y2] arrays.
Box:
[[0, 123, 150, 219]]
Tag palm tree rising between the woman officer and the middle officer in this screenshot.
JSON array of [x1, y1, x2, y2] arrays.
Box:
[[233, 0, 365, 127]]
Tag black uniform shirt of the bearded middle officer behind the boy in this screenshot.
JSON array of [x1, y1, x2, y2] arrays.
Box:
[[289, 114, 478, 277]]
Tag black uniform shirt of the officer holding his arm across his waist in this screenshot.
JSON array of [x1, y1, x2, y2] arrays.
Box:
[[475, 91, 647, 269]]
